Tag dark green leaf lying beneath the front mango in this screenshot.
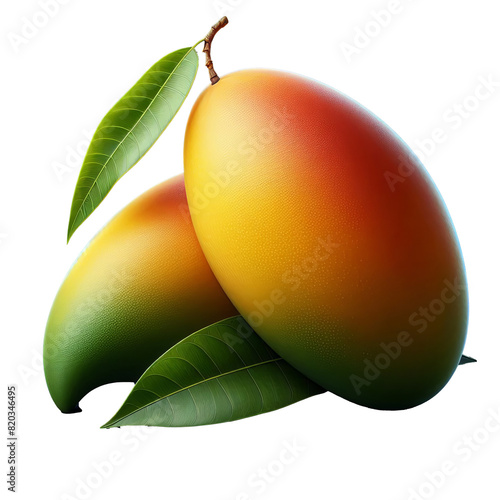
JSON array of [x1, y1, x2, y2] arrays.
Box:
[[103, 316, 325, 428]]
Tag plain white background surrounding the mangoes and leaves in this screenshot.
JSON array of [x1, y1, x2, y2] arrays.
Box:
[[0, 0, 500, 500]]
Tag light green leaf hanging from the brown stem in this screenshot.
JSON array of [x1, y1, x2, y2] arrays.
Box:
[[68, 45, 198, 241]]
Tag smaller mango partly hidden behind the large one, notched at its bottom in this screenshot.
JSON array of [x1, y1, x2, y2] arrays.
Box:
[[44, 175, 237, 413]]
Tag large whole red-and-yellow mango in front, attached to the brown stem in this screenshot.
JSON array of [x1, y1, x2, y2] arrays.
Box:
[[184, 70, 468, 410]]
